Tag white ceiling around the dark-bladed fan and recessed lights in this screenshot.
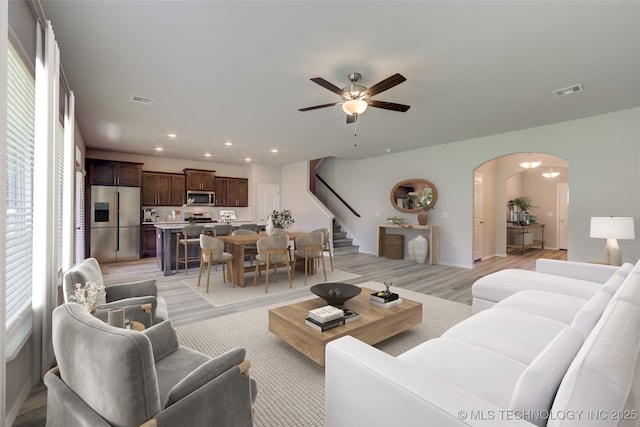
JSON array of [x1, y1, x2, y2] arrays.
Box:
[[43, 0, 640, 165]]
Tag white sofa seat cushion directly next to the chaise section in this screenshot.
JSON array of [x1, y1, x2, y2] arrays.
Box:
[[494, 291, 587, 325]]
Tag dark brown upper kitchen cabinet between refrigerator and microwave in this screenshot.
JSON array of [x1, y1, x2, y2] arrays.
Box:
[[142, 172, 185, 206]]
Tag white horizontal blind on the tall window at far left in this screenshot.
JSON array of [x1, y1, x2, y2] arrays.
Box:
[[5, 43, 35, 330]]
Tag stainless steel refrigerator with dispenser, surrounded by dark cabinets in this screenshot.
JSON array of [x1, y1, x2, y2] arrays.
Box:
[[91, 185, 141, 262]]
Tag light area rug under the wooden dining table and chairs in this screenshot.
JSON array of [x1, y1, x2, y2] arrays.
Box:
[[182, 266, 360, 307]]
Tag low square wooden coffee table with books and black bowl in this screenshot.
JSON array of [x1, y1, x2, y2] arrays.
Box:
[[269, 288, 422, 366]]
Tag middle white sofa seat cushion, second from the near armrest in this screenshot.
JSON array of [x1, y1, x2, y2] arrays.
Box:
[[442, 307, 567, 365]]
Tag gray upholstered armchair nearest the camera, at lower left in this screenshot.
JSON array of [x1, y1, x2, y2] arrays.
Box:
[[44, 303, 257, 427]]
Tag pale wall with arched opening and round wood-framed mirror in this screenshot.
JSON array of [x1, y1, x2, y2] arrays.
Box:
[[319, 108, 640, 267]]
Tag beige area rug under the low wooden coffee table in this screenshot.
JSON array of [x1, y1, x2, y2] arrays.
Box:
[[176, 282, 471, 427]]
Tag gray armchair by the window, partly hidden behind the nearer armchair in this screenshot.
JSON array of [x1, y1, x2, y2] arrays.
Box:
[[63, 258, 169, 327]]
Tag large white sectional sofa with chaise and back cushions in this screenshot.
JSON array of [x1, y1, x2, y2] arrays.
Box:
[[325, 260, 640, 427]]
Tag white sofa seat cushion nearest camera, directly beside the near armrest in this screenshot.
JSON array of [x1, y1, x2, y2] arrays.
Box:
[[397, 338, 526, 408]]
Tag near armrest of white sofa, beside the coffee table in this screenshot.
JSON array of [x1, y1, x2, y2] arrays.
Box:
[[325, 336, 532, 427]]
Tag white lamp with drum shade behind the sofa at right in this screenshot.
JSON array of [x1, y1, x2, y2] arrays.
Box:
[[590, 216, 636, 265]]
